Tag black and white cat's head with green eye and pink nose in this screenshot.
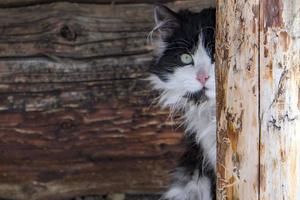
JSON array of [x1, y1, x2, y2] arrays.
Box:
[[150, 6, 215, 108]]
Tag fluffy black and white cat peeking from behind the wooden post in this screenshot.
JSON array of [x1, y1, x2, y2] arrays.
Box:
[[149, 6, 216, 200]]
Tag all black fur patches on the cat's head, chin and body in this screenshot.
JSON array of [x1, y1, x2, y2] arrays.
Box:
[[150, 7, 216, 199]]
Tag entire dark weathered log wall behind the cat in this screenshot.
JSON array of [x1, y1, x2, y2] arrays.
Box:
[[0, 0, 213, 200]]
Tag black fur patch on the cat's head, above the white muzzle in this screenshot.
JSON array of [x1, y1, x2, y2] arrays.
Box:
[[150, 8, 216, 81]]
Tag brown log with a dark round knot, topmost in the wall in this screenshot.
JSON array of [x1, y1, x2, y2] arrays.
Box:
[[0, 1, 213, 59]]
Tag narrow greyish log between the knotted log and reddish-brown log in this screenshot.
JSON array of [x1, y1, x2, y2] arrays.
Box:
[[0, 54, 151, 84]]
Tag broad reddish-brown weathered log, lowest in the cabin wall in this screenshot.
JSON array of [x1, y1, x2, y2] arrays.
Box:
[[0, 74, 188, 199]]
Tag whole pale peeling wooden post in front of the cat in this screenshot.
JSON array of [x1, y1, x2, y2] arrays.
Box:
[[216, 0, 300, 200]]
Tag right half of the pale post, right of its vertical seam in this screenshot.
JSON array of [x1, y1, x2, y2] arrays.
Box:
[[260, 0, 300, 200]]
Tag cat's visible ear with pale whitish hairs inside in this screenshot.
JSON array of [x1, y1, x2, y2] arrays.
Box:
[[154, 5, 179, 40]]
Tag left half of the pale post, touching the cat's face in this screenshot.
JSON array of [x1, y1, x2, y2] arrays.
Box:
[[216, 0, 259, 200]]
